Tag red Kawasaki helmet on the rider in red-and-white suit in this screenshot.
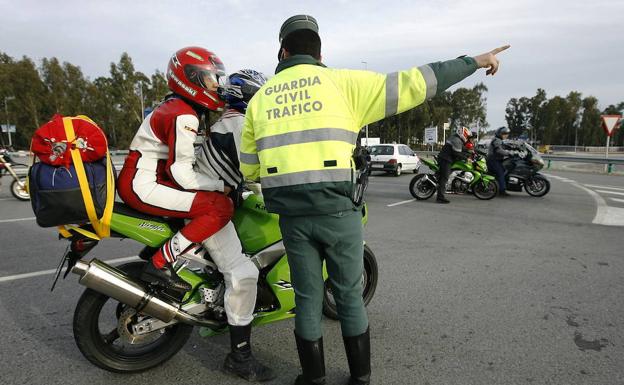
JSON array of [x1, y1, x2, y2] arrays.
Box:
[[167, 47, 226, 111]]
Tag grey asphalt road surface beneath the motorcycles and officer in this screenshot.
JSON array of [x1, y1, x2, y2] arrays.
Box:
[[0, 172, 624, 385]]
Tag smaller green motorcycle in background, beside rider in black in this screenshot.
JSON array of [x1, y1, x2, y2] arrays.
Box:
[[409, 154, 498, 200]]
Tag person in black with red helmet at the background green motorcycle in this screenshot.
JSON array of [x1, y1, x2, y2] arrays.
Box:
[[436, 127, 472, 203]]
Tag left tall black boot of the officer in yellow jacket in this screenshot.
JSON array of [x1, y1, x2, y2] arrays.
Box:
[[295, 332, 325, 385]]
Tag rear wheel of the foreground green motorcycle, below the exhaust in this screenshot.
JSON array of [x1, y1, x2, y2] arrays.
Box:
[[74, 261, 193, 373]]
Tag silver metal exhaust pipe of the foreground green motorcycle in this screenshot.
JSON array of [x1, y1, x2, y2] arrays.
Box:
[[71, 259, 221, 329]]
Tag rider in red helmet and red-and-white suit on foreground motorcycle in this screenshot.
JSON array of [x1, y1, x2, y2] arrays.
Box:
[[117, 47, 275, 381]]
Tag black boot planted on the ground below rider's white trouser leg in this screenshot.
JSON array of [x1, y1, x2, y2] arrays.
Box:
[[223, 324, 276, 382]]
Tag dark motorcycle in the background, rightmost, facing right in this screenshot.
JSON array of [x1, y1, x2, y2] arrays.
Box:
[[503, 140, 550, 197]]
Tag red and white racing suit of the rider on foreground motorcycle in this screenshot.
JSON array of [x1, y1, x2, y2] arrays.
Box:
[[117, 97, 258, 326]]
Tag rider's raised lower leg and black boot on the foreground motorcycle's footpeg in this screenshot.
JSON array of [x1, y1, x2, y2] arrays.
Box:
[[141, 232, 194, 293]]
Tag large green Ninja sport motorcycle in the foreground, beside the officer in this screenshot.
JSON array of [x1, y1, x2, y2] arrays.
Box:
[[52, 192, 378, 373]]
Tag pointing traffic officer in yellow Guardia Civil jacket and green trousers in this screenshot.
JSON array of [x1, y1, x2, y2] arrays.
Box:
[[240, 15, 507, 385]]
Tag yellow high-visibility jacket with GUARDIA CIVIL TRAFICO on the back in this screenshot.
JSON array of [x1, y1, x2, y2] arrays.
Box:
[[240, 55, 477, 215]]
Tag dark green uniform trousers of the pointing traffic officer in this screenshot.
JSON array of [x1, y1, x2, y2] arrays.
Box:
[[279, 209, 368, 341]]
